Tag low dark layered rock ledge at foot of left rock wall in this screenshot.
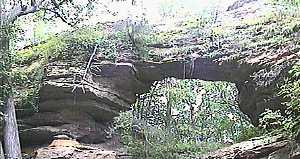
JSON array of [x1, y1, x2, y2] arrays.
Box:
[[20, 109, 110, 145]]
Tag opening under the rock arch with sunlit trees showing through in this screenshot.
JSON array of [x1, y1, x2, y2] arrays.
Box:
[[116, 78, 255, 148]]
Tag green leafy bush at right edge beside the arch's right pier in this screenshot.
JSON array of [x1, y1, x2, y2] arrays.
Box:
[[259, 63, 300, 138]]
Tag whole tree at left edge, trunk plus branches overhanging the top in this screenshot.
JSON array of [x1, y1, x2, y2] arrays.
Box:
[[0, 0, 97, 159]]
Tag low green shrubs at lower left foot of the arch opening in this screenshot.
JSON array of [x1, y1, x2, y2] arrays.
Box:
[[115, 112, 222, 159]]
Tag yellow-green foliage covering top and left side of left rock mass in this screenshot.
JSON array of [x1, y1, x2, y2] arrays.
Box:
[[11, 27, 102, 110]]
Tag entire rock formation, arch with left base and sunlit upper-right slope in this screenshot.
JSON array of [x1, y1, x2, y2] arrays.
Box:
[[20, 0, 300, 152]]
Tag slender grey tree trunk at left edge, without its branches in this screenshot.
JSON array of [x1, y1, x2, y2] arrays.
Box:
[[0, 25, 22, 159]]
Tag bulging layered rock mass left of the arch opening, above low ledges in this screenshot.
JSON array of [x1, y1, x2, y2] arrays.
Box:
[[39, 63, 141, 121]]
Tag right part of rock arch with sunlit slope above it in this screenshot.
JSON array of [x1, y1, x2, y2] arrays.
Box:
[[135, 0, 300, 125]]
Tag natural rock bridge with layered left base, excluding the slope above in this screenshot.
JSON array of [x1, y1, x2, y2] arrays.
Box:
[[21, 52, 296, 143]]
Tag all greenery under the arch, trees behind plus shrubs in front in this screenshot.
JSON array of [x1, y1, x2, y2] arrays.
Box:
[[115, 78, 257, 158]]
